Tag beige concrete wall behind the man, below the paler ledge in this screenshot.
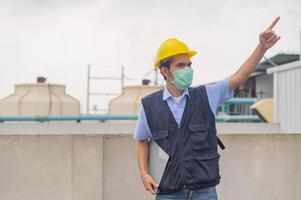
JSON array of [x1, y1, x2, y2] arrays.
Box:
[[0, 127, 301, 200]]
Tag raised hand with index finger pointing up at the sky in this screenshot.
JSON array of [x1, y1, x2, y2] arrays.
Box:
[[259, 17, 280, 50]]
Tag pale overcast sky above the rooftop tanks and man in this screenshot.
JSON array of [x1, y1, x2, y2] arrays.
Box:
[[0, 0, 301, 112]]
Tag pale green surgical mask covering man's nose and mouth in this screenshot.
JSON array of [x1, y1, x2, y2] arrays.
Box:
[[171, 67, 193, 90]]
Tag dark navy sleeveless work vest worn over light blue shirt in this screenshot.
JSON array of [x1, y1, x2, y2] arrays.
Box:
[[142, 85, 221, 194]]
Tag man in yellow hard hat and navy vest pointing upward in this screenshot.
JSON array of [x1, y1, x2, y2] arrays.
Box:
[[134, 17, 280, 200]]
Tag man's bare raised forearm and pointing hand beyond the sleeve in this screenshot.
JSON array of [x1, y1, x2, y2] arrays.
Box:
[[229, 17, 280, 90]]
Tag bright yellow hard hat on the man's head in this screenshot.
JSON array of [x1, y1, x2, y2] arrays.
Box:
[[155, 38, 197, 67]]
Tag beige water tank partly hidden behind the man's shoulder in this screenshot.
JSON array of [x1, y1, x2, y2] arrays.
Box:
[[109, 85, 163, 115]]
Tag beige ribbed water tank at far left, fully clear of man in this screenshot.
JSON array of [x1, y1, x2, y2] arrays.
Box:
[[0, 83, 80, 116]]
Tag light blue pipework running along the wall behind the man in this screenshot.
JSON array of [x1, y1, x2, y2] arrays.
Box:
[[0, 98, 261, 122]]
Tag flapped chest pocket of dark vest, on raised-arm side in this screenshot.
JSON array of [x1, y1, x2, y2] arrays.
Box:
[[188, 122, 211, 151]]
